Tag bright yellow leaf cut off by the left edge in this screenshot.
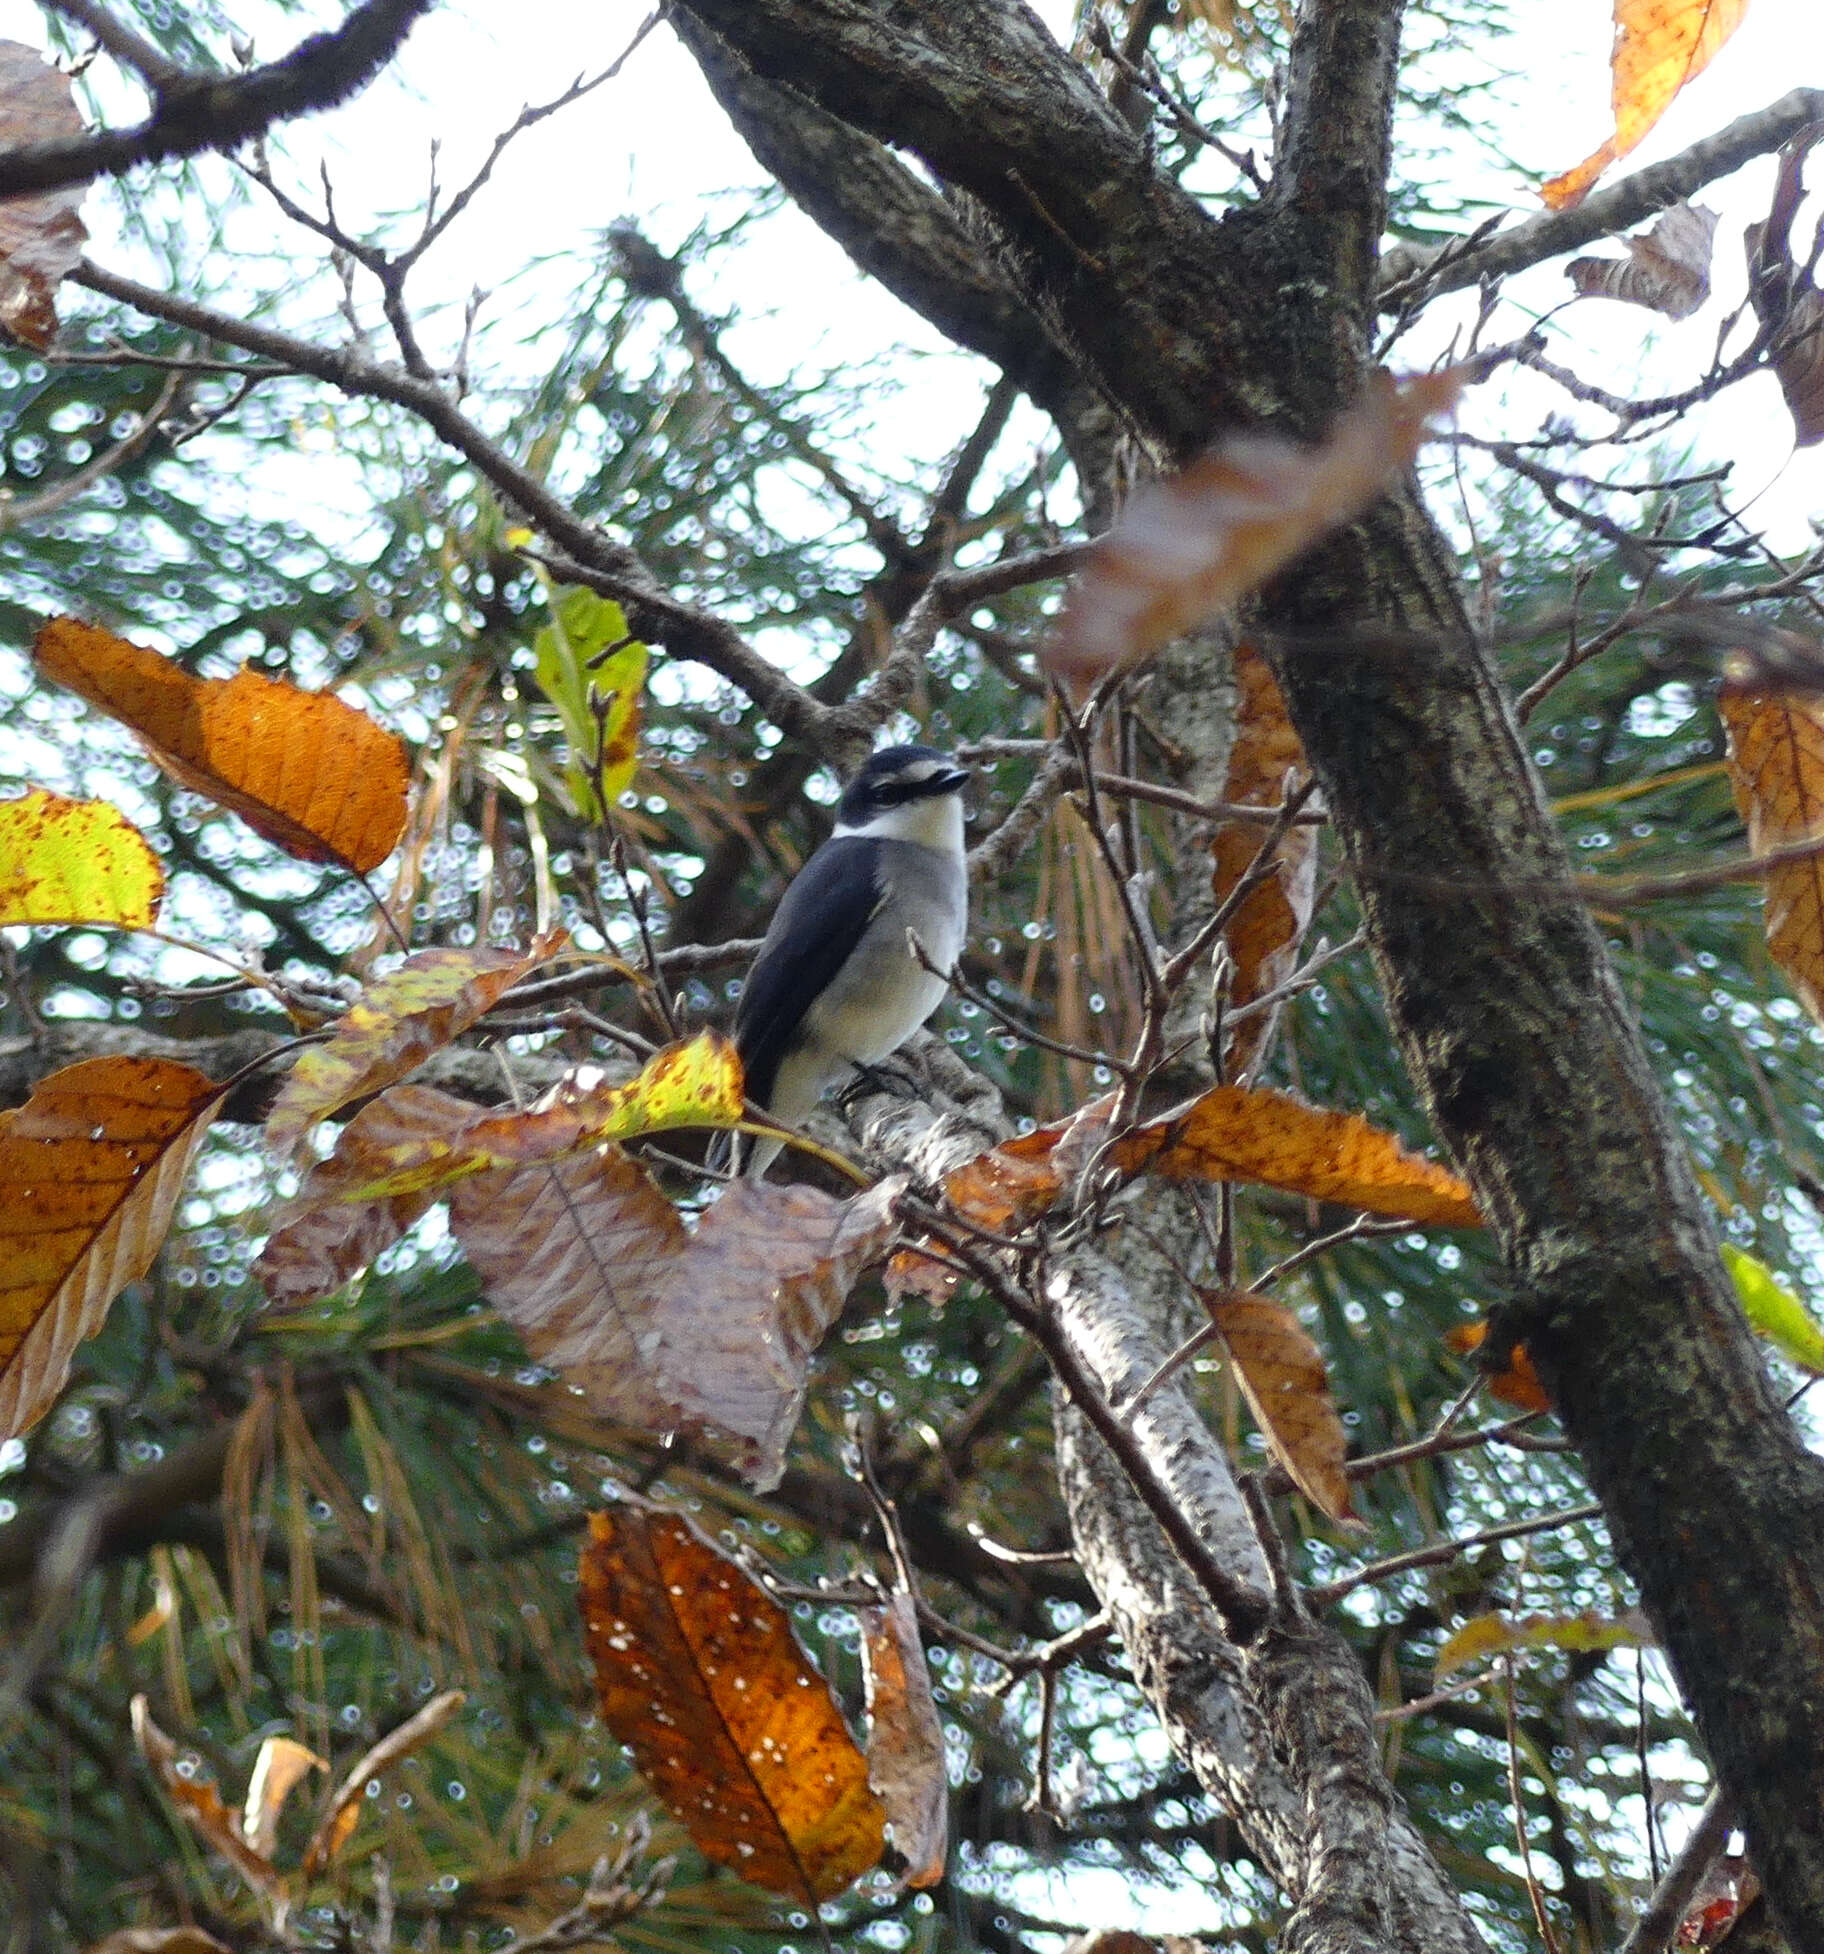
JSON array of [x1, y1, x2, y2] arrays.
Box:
[[0, 781, 164, 930]]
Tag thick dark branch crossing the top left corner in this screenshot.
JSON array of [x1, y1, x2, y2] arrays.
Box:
[[0, 0, 432, 197]]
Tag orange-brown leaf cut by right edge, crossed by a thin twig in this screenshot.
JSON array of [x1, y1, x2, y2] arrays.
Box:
[[1716, 692, 1824, 1024]]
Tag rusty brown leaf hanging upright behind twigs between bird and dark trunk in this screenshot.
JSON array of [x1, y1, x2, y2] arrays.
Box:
[[1210, 643, 1318, 1073]]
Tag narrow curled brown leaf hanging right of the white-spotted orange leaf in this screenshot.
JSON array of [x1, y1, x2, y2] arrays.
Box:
[[858, 1593, 950, 1886]]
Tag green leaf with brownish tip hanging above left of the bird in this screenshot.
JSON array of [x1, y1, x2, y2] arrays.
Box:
[[532, 588, 647, 821]]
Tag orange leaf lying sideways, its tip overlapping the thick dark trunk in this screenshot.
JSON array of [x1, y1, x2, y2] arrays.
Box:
[[1110, 1086, 1482, 1227]]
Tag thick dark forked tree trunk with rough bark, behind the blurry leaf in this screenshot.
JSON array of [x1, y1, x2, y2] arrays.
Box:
[[672, 0, 1824, 1950]]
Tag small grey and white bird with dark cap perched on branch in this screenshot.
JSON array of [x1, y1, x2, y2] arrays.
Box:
[[735, 746, 970, 1174]]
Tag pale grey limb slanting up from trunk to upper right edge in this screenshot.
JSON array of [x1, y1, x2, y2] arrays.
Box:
[[1378, 88, 1824, 307]]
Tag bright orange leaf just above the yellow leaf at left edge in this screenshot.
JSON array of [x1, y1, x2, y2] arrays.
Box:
[[31, 617, 411, 875]]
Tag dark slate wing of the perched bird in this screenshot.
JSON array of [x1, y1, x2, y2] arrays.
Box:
[[735, 834, 882, 1106]]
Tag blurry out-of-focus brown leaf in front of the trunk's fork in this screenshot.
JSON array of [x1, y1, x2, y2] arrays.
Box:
[[1044, 369, 1464, 696]]
